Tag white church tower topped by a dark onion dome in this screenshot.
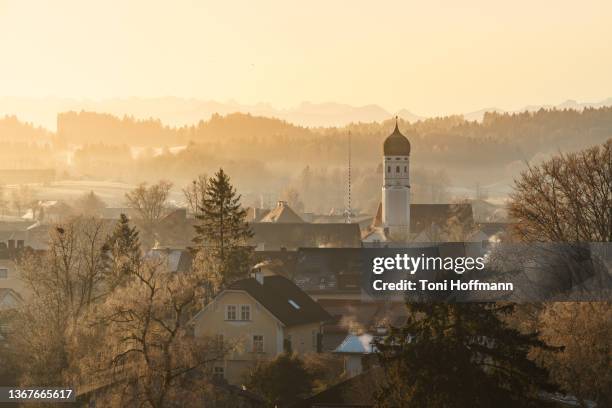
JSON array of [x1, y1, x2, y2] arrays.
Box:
[[382, 117, 410, 241]]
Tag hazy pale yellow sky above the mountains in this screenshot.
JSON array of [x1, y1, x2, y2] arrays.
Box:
[[0, 0, 612, 115]]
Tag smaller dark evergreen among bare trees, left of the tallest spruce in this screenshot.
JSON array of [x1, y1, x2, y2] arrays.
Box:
[[105, 214, 142, 289]]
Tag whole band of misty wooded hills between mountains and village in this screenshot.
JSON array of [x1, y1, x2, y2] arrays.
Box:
[[0, 107, 612, 211]]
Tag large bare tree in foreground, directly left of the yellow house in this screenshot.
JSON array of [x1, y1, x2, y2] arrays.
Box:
[[99, 259, 224, 408]]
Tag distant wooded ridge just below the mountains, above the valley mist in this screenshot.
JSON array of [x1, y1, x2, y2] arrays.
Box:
[[58, 107, 612, 164]]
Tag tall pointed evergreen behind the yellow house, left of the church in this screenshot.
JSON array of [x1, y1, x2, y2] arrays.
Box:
[[193, 169, 253, 286]]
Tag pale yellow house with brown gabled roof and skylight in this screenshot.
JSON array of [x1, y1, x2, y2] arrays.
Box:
[[191, 268, 332, 385]]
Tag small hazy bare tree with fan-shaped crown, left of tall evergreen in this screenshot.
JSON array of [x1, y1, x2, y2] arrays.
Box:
[[125, 180, 172, 228]]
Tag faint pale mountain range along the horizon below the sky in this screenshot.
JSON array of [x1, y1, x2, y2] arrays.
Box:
[[0, 97, 612, 130]]
